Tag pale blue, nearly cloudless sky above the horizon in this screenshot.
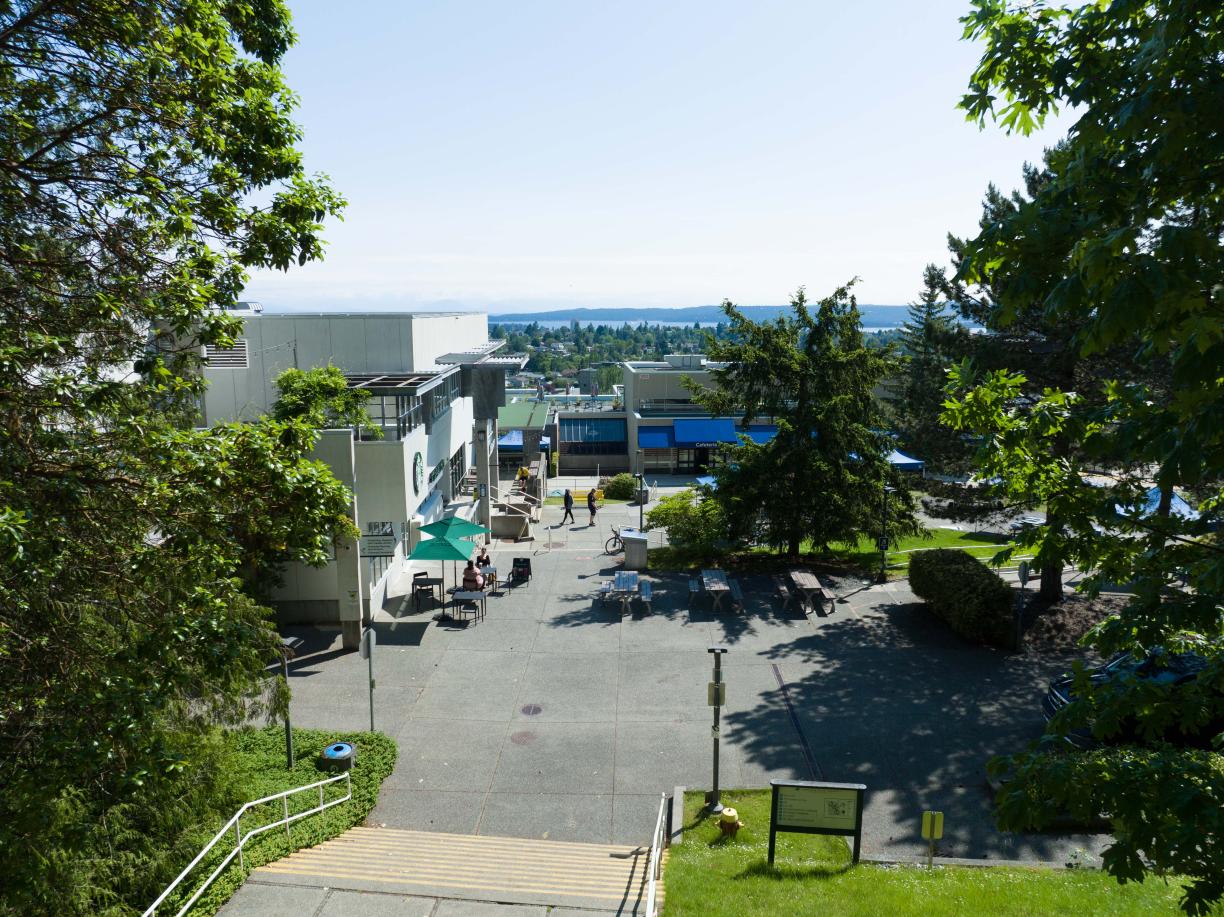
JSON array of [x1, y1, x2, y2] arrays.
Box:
[[245, 0, 1066, 313]]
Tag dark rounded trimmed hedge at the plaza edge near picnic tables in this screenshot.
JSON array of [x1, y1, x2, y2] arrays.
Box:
[[909, 548, 1013, 648]]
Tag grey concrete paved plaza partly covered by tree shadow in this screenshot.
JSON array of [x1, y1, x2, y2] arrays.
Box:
[[281, 501, 1100, 861]]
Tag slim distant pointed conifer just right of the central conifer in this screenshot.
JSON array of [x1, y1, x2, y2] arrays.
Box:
[[892, 264, 966, 469]]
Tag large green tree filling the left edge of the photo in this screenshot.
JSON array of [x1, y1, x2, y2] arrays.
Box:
[[0, 0, 350, 913]]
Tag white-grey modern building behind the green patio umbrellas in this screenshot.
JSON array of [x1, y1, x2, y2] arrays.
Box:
[[201, 307, 523, 645]]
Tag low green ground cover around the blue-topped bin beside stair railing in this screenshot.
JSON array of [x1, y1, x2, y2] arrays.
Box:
[[166, 726, 395, 917]]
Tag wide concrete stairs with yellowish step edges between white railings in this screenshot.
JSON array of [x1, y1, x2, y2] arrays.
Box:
[[247, 828, 662, 915]]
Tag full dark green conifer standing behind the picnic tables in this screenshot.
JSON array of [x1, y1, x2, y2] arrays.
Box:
[[692, 284, 917, 557]]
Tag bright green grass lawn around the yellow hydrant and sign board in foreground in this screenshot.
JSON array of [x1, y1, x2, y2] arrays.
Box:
[[663, 790, 1199, 917]]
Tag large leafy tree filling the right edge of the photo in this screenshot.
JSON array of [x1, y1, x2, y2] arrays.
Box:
[[949, 0, 1224, 912]]
